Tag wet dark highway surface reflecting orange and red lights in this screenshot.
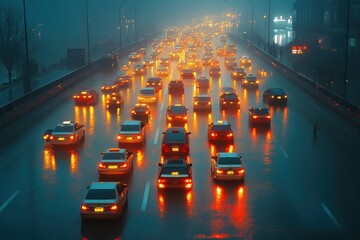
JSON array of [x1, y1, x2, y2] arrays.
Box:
[[0, 34, 360, 239]]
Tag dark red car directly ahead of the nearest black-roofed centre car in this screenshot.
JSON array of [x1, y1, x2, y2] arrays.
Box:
[[161, 127, 191, 157]]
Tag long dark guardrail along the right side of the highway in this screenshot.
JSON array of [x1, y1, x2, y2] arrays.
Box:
[[229, 35, 360, 130]]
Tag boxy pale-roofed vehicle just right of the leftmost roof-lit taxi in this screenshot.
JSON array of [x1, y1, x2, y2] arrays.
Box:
[[117, 120, 146, 144]]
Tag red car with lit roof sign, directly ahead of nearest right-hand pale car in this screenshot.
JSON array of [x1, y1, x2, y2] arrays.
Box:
[[208, 120, 234, 143]]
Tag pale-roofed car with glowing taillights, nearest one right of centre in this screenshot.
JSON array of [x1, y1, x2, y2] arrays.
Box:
[[210, 152, 245, 181]]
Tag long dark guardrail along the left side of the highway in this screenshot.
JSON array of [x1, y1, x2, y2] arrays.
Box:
[[0, 39, 148, 130]]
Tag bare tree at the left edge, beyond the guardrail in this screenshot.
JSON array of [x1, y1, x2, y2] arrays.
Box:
[[0, 6, 24, 83]]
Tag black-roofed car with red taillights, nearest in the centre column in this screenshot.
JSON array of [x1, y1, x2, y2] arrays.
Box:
[[157, 159, 193, 190]]
